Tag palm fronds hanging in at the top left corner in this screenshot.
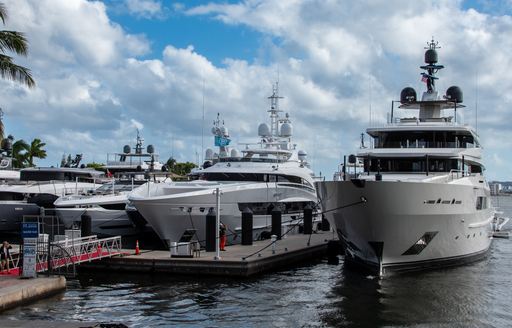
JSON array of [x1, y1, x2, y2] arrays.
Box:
[[0, 3, 36, 88]]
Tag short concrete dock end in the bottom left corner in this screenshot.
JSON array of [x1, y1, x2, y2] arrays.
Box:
[[0, 275, 66, 312]]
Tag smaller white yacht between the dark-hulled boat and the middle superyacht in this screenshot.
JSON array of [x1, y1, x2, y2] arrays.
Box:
[[54, 130, 171, 237]]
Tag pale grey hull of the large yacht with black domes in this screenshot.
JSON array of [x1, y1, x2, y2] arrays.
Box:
[[317, 176, 494, 274]]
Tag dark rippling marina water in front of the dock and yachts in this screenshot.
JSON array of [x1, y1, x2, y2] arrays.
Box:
[[0, 196, 512, 327]]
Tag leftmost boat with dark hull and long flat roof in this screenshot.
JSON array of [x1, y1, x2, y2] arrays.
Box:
[[0, 167, 102, 233]]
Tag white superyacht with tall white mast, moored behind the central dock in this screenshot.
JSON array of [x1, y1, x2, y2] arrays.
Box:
[[129, 84, 317, 245]]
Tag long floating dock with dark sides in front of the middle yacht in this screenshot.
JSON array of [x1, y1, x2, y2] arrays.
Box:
[[80, 232, 336, 277]]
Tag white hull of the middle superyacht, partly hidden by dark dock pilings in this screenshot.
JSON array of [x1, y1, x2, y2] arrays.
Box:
[[129, 183, 317, 244]]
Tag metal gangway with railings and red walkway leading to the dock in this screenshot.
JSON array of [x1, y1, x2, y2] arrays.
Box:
[[36, 235, 122, 274]]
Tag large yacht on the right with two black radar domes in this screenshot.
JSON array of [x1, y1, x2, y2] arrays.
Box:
[[317, 40, 495, 275]]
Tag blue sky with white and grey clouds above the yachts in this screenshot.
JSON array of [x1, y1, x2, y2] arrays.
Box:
[[0, 0, 512, 180]]
